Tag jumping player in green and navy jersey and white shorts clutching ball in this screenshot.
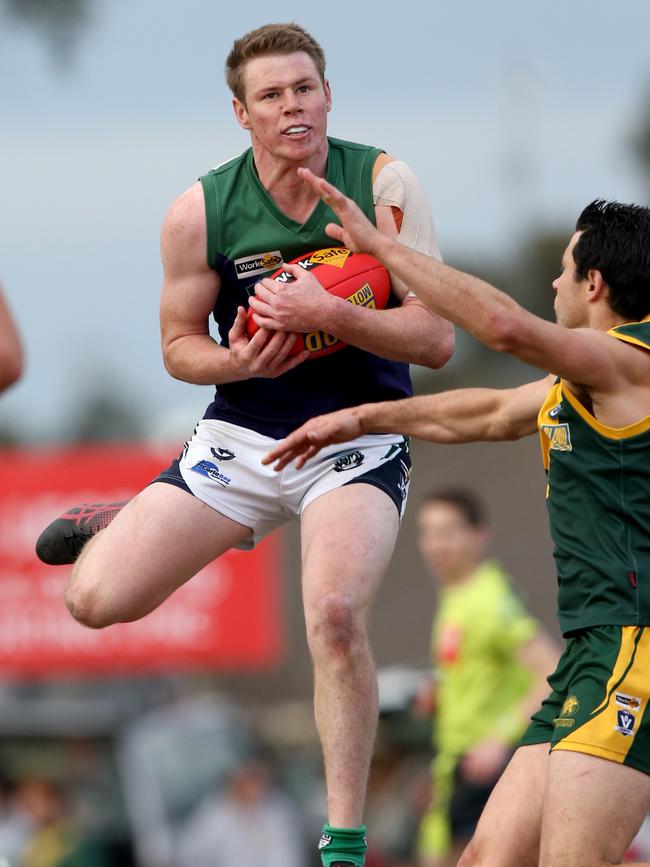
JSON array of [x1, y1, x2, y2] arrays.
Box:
[[45, 24, 453, 867]]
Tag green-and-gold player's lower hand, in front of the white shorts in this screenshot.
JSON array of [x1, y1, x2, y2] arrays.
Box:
[[262, 407, 364, 472]]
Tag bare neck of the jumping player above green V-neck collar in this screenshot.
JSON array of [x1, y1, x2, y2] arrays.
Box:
[[253, 143, 328, 223]]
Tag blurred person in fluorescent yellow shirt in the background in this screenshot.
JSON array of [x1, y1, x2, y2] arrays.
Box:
[[416, 488, 559, 867]]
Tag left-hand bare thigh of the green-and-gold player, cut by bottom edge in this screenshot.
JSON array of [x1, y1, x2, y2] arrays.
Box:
[[458, 744, 549, 867]]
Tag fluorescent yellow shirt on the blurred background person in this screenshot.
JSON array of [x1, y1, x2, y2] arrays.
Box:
[[431, 561, 538, 756]]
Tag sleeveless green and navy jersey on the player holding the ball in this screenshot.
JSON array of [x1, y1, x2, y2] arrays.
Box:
[[200, 138, 412, 438]]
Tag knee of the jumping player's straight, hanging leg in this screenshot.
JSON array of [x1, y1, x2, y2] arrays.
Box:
[[306, 593, 365, 657]]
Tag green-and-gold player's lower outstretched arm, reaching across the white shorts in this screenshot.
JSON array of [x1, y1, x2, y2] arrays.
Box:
[[263, 376, 553, 470]]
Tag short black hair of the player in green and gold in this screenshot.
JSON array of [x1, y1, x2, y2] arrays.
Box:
[[573, 199, 650, 322]]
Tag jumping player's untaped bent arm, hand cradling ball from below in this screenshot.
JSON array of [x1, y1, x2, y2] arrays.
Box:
[[160, 184, 304, 385]]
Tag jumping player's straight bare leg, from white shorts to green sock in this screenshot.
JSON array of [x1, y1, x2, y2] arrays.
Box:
[[302, 484, 399, 863]]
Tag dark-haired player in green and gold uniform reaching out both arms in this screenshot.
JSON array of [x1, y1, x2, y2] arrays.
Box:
[[266, 178, 650, 867]]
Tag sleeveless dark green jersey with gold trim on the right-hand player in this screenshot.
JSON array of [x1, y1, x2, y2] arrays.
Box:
[[538, 317, 650, 635]]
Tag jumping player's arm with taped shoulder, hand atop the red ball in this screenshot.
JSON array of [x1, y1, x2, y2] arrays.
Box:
[[246, 154, 454, 369]]
